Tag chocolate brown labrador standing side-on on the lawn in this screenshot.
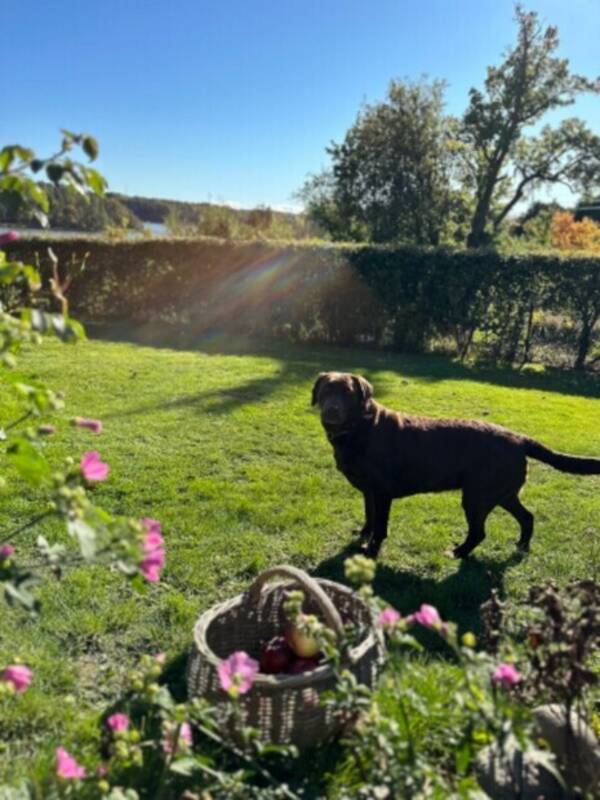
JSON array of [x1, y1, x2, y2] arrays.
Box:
[[312, 372, 600, 558]]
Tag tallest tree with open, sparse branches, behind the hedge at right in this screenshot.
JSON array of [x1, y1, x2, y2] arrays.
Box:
[[461, 5, 600, 247]]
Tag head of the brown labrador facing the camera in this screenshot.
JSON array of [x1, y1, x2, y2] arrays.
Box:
[[312, 372, 373, 429]]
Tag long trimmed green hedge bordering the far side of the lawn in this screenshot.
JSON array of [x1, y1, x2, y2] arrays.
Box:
[[4, 233, 600, 367]]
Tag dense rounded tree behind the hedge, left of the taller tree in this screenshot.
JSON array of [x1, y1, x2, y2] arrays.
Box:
[[300, 81, 454, 244]]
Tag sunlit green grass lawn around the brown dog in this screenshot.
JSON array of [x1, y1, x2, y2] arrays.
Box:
[[0, 328, 600, 792]]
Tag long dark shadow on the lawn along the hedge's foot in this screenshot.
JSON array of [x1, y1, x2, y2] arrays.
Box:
[[87, 323, 600, 405]]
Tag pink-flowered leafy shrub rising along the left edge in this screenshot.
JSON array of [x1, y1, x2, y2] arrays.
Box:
[[0, 136, 165, 611]]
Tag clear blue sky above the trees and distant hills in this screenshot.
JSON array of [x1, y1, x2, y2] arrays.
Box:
[[0, 0, 600, 207]]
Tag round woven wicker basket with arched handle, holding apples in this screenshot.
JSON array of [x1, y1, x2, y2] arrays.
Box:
[[187, 566, 384, 749]]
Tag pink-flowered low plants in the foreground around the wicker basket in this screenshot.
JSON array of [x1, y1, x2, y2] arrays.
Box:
[[0, 556, 598, 800]]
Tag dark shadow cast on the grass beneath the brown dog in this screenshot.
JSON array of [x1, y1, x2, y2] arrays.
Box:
[[313, 545, 526, 635]]
